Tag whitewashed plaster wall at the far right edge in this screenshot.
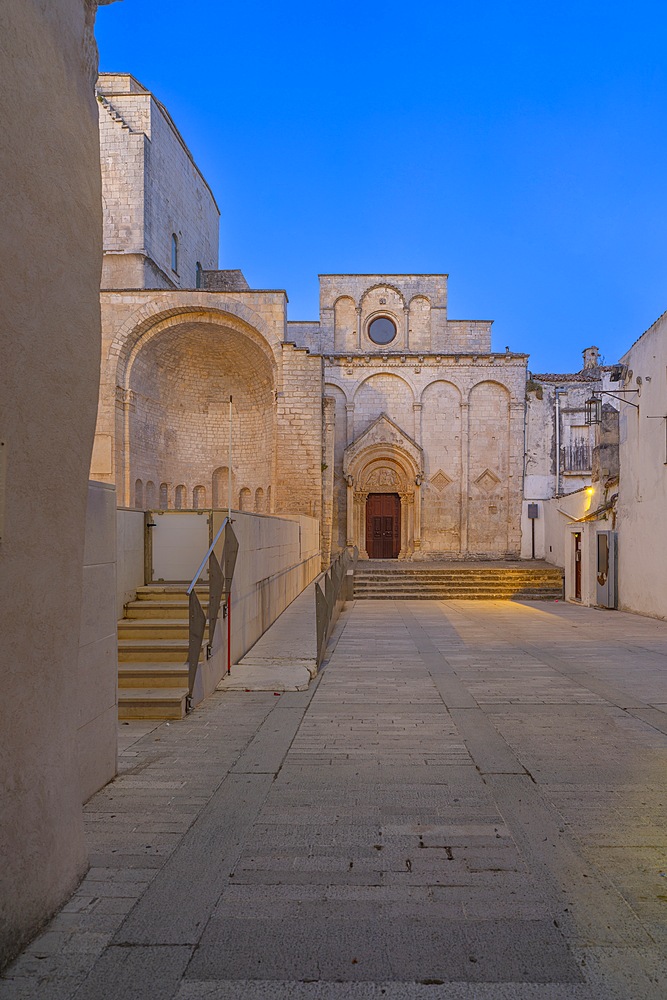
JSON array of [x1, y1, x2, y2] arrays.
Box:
[[617, 314, 667, 618]]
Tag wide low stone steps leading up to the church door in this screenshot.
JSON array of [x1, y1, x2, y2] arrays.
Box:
[[354, 560, 563, 601]]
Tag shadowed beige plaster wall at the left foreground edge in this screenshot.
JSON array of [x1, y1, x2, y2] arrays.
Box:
[[0, 0, 102, 962]]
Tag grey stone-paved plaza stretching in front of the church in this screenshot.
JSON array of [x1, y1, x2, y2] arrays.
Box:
[[0, 601, 667, 1000]]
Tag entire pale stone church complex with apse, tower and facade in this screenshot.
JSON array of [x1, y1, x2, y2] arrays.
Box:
[[91, 74, 527, 560]]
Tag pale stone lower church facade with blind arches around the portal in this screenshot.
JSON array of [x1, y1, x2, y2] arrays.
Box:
[[325, 354, 527, 558]]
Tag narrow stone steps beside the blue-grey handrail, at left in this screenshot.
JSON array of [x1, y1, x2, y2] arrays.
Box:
[[118, 584, 208, 719]]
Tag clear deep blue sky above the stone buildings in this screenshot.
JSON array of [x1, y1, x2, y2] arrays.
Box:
[[97, 0, 667, 372]]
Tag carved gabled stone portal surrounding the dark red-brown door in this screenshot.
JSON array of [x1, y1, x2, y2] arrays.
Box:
[[343, 414, 423, 559]]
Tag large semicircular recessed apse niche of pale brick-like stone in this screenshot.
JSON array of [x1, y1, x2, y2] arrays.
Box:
[[117, 314, 276, 508]]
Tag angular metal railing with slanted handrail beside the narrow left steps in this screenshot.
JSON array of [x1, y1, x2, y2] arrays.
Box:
[[187, 517, 239, 709]]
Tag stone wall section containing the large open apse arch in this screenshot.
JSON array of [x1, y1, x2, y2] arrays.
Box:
[[91, 291, 285, 507]]
